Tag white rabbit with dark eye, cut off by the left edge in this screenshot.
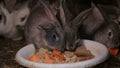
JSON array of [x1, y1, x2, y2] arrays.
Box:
[[0, 3, 15, 36]]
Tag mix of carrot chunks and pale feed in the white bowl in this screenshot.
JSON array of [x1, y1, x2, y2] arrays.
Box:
[[28, 45, 94, 64]]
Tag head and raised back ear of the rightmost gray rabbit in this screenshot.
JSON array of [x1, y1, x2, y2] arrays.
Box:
[[94, 4, 120, 48]]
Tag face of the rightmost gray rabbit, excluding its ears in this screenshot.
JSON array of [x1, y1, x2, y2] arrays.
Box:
[[94, 22, 120, 48]]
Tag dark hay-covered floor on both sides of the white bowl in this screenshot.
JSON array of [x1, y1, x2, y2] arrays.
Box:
[[0, 39, 120, 68]]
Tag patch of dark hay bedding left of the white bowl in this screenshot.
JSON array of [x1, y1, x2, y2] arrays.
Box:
[[0, 39, 25, 68]]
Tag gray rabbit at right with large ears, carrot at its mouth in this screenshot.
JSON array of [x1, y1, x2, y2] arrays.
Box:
[[73, 4, 120, 48]]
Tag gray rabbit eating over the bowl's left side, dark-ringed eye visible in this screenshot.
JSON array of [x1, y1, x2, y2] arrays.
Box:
[[25, 0, 65, 51]]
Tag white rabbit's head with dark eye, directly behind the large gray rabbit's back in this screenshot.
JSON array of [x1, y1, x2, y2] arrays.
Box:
[[13, 2, 30, 34]]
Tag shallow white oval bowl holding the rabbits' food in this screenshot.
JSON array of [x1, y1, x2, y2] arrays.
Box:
[[15, 40, 109, 68]]
